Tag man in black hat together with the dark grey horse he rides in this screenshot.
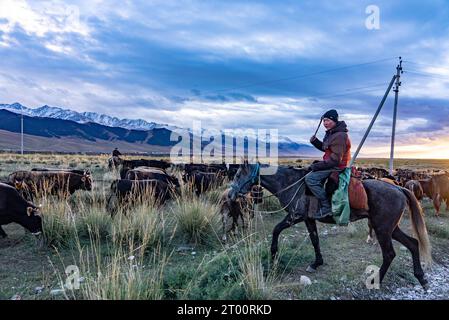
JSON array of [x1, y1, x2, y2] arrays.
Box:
[[229, 110, 432, 290]]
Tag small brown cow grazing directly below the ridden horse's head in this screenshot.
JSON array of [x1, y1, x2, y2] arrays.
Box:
[[220, 185, 262, 242]]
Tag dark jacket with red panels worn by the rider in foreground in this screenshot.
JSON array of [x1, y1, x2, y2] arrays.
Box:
[[311, 121, 351, 171]]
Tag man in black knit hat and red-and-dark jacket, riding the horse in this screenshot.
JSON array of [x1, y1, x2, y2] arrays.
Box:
[[305, 109, 351, 219]]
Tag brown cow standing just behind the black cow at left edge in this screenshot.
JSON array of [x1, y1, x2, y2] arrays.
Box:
[[8, 171, 92, 196]]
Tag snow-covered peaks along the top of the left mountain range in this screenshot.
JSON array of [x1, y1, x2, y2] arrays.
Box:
[[0, 102, 176, 130]]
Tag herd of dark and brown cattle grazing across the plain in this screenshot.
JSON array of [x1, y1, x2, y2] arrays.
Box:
[[0, 157, 449, 239]]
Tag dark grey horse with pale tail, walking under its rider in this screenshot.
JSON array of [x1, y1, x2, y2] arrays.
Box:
[[230, 162, 432, 290]]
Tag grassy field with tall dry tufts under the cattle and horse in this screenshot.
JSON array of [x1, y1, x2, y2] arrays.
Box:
[[0, 154, 449, 300]]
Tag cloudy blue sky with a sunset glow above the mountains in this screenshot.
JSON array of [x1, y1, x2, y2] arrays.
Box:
[[0, 0, 449, 158]]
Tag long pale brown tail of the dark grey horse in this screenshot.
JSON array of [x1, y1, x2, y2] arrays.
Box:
[[401, 188, 432, 267]]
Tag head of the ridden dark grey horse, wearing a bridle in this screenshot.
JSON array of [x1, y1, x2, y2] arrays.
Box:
[[229, 161, 260, 201]]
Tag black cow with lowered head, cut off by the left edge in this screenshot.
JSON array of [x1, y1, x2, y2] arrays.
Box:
[[0, 183, 42, 238]]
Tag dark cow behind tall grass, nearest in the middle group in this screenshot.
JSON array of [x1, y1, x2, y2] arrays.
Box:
[[107, 179, 175, 215]]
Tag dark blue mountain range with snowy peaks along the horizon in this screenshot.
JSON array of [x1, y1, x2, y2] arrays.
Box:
[[0, 103, 318, 157]]
